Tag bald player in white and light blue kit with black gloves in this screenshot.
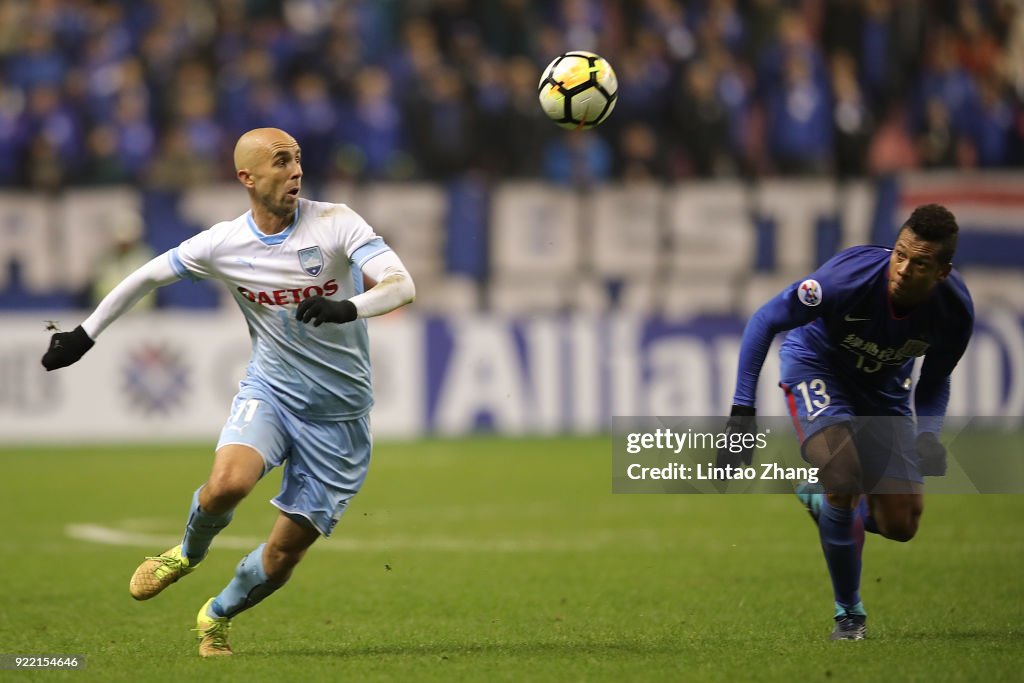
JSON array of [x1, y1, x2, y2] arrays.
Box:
[[42, 128, 416, 656]]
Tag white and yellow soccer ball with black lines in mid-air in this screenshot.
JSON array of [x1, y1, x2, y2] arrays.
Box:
[[537, 50, 618, 130]]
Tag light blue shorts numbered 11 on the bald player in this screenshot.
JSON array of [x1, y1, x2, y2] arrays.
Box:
[[217, 380, 373, 536]]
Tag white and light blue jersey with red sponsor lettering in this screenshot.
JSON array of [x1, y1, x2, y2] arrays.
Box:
[[169, 200, 389, 420]]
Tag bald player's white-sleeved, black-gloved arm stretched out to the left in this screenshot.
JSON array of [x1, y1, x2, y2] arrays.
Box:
[[42, 253, 184, 371]]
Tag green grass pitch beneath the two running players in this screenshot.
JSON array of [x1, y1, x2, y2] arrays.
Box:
[[0, 438, 1024, 683]]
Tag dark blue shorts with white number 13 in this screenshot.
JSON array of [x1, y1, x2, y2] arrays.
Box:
[[779, 347, 924, 485]]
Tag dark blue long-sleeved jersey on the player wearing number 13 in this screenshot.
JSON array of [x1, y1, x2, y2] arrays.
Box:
[[733, 247, 974, 431]]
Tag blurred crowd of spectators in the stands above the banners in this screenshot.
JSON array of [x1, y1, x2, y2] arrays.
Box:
[[0, 0, 1024, 190]]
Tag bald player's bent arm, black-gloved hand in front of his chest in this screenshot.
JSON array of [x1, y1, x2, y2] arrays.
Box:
[[295, 251, 416, 328]]
